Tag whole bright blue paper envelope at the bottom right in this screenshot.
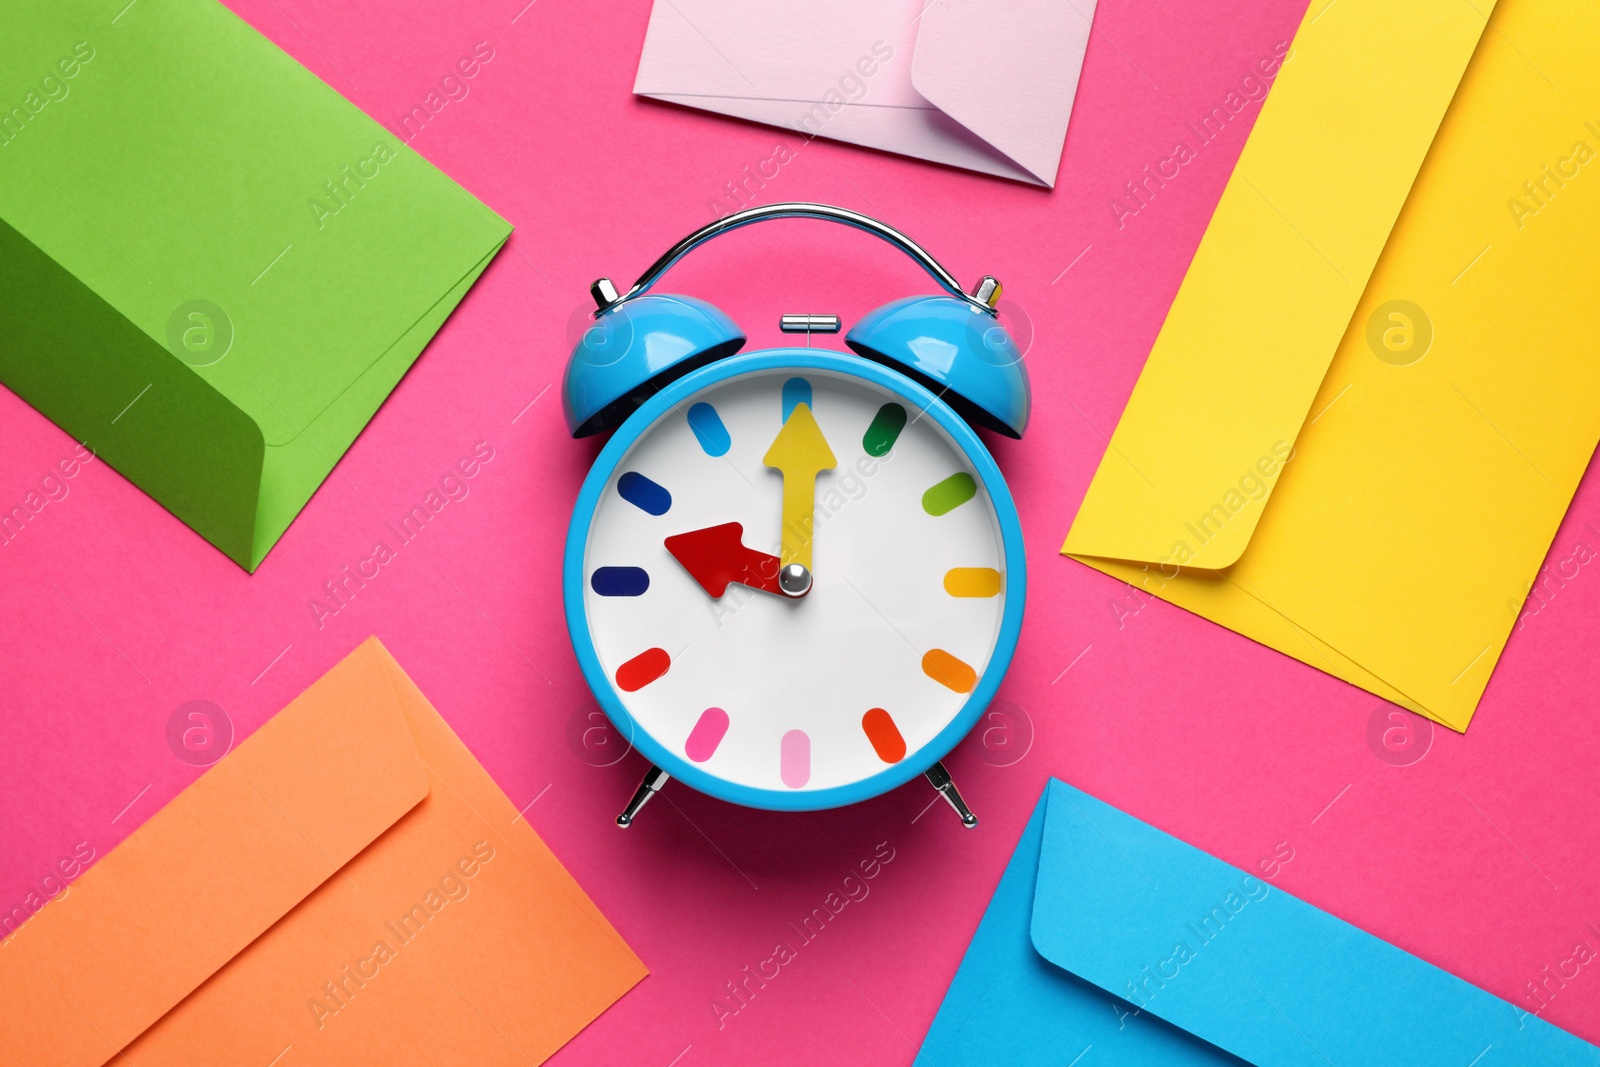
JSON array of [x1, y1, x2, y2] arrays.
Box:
[[917, 779, 1600, 1067]]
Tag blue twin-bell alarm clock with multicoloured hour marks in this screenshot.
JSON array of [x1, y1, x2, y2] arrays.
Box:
[[562, 203, 1030, 827]]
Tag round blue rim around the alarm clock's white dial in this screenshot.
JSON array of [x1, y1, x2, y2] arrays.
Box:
[[562, 347, 1027, 811]]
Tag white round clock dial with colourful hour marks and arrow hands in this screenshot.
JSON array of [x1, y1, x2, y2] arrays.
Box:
[[582, 368, 1006, 793]]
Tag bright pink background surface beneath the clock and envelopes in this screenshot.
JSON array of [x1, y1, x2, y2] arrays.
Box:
[[0, 0, 1600, 1067]]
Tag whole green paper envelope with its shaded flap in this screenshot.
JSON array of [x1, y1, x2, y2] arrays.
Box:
[[0, 0, 510, 571]]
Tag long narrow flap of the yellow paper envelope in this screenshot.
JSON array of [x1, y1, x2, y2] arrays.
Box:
[[1062, 0, 1493, 569]]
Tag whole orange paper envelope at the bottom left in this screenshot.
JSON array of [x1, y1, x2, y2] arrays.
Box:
[[0, 638, 645, 1067]]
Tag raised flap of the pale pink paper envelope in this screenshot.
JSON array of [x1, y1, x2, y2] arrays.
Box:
[[910, 0, 1094, 186]]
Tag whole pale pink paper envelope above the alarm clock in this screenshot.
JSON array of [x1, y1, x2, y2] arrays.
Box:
[[634, 0, 1094, 187]]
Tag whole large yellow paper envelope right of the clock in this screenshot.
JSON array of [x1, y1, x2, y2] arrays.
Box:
[[1062, 0, 1600, 729]]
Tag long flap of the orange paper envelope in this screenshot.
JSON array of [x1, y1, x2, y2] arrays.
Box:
[[0, 640, 427, 1067]]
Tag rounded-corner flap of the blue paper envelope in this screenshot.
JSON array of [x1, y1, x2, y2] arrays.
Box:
[[1032, 781, 1600, 1067]]
